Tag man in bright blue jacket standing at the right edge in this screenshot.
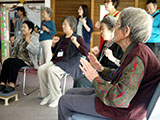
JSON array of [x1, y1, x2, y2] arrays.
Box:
[[146, 0, 160, 58]]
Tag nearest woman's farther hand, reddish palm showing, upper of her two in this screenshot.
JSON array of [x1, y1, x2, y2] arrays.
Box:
[[88, 53, 104, 72]]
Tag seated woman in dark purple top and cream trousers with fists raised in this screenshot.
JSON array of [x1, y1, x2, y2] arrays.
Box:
[[38, 16, 88, 107]]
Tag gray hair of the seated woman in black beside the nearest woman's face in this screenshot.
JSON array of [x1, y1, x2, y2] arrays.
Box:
[[101, 16, 117, 31]]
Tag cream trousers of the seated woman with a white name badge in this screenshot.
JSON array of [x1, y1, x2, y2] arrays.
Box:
[[38, 61, 65, 102]]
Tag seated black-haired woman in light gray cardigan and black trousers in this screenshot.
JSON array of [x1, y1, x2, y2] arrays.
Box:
[[0, 21, 39, 93]]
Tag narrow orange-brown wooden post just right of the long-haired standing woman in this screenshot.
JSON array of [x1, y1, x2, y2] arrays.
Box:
[[90, 0, 95, 48]]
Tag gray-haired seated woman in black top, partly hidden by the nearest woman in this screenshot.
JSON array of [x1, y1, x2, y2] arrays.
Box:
[[74, 16, 123, 87]]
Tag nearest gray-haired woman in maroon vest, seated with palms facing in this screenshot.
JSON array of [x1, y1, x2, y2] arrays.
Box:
[[58, 7, 160, 120]]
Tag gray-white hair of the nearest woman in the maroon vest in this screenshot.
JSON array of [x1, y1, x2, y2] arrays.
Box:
[[119, 7, 153, 43]]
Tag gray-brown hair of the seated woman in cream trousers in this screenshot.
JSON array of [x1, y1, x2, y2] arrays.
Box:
[[62, 16, 77, 32]]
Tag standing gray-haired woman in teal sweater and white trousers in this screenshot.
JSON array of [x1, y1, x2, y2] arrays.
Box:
[[39, 7, 56, 64]]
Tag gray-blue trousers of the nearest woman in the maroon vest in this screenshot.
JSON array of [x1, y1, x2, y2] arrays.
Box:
[[58, 88, 112, 120]]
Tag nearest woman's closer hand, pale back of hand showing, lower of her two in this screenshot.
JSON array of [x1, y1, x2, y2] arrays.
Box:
[[79, 58, 99, 82]]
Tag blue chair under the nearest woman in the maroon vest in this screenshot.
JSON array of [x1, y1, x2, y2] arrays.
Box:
[[72, 82, 160, 120]]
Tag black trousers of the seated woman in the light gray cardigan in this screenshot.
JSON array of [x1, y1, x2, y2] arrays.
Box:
[[0, 58, 27, 84]]
